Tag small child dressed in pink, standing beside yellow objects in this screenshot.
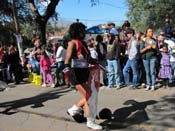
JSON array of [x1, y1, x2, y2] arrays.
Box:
[[40, 51, 55, 87]]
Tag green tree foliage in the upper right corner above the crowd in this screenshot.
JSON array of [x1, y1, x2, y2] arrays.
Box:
[[126, 0, 175, 31]]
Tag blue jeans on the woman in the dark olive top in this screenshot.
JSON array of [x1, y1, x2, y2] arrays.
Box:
[[143, 58, 156, 86]]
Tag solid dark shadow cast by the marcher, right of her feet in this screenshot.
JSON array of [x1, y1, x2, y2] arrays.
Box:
[[101, 100, 157, 130]]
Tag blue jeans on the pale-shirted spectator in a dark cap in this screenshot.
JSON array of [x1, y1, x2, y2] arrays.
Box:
[[123, 59, 139, 87]]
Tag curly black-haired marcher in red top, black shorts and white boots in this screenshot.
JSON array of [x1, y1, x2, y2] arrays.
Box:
[[63, 22, 102, 130]]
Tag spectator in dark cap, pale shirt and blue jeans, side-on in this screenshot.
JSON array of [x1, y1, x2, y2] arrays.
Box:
[[123, 28, 139, 89]]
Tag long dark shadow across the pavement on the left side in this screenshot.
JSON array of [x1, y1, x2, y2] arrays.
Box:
[[0, 88, 71, 115]]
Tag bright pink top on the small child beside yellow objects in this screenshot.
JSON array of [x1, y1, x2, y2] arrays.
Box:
[[40, 58, 51, 71]]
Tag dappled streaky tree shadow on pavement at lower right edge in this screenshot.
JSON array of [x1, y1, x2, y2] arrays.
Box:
[[147, 94, 175, 128]]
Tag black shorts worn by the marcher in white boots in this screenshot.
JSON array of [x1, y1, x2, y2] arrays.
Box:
[[70, 68, 89, 85]]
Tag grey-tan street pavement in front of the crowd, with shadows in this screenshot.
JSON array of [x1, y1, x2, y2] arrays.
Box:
[[0, 82, 175, 131]]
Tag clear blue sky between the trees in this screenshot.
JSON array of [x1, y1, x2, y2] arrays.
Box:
[[56, 0, 127, 27]]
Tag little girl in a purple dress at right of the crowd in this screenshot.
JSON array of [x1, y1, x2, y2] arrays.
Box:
[[159, 44, 172, 88]]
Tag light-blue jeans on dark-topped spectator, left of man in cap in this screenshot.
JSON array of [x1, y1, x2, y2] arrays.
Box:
[[107, 60, 120, 87]]
